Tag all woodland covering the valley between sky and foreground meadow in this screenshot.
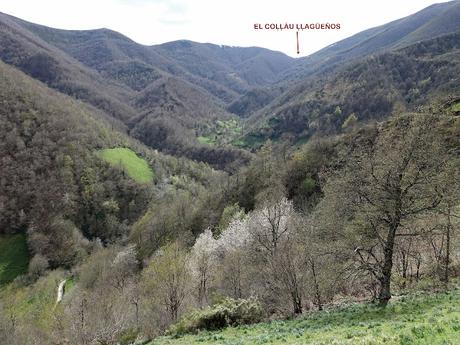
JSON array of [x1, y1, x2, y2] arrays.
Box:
[[0, 1, 460, 345]]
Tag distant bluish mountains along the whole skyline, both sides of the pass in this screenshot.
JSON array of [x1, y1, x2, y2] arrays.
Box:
[[0, 0, 460, 159]]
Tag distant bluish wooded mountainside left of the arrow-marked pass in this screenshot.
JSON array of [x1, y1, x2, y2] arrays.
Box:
[[0, 14, 276, 171]]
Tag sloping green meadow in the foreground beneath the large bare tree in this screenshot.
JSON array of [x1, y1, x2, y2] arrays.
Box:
[[153, 290, 460, 345]]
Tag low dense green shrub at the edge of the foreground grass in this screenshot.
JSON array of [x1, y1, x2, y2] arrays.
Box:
[[168, 298, 262, 334]]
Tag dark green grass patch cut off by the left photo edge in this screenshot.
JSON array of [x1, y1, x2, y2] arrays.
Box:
[[0, 234, 29, 286]]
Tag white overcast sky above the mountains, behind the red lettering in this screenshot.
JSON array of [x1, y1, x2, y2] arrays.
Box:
[[0, 0, 452, 56]]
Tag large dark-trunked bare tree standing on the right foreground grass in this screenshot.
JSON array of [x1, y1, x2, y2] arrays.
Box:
[[327, 115, 446, 306]]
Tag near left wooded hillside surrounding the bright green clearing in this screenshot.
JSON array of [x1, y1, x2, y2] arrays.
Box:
[[0, 59, 234, 258]]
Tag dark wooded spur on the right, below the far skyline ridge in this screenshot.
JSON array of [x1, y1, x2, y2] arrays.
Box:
[[246, 32, 460, 145]]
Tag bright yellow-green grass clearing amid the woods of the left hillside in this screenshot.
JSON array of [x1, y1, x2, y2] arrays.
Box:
[[100, 148, 154, 183]]
